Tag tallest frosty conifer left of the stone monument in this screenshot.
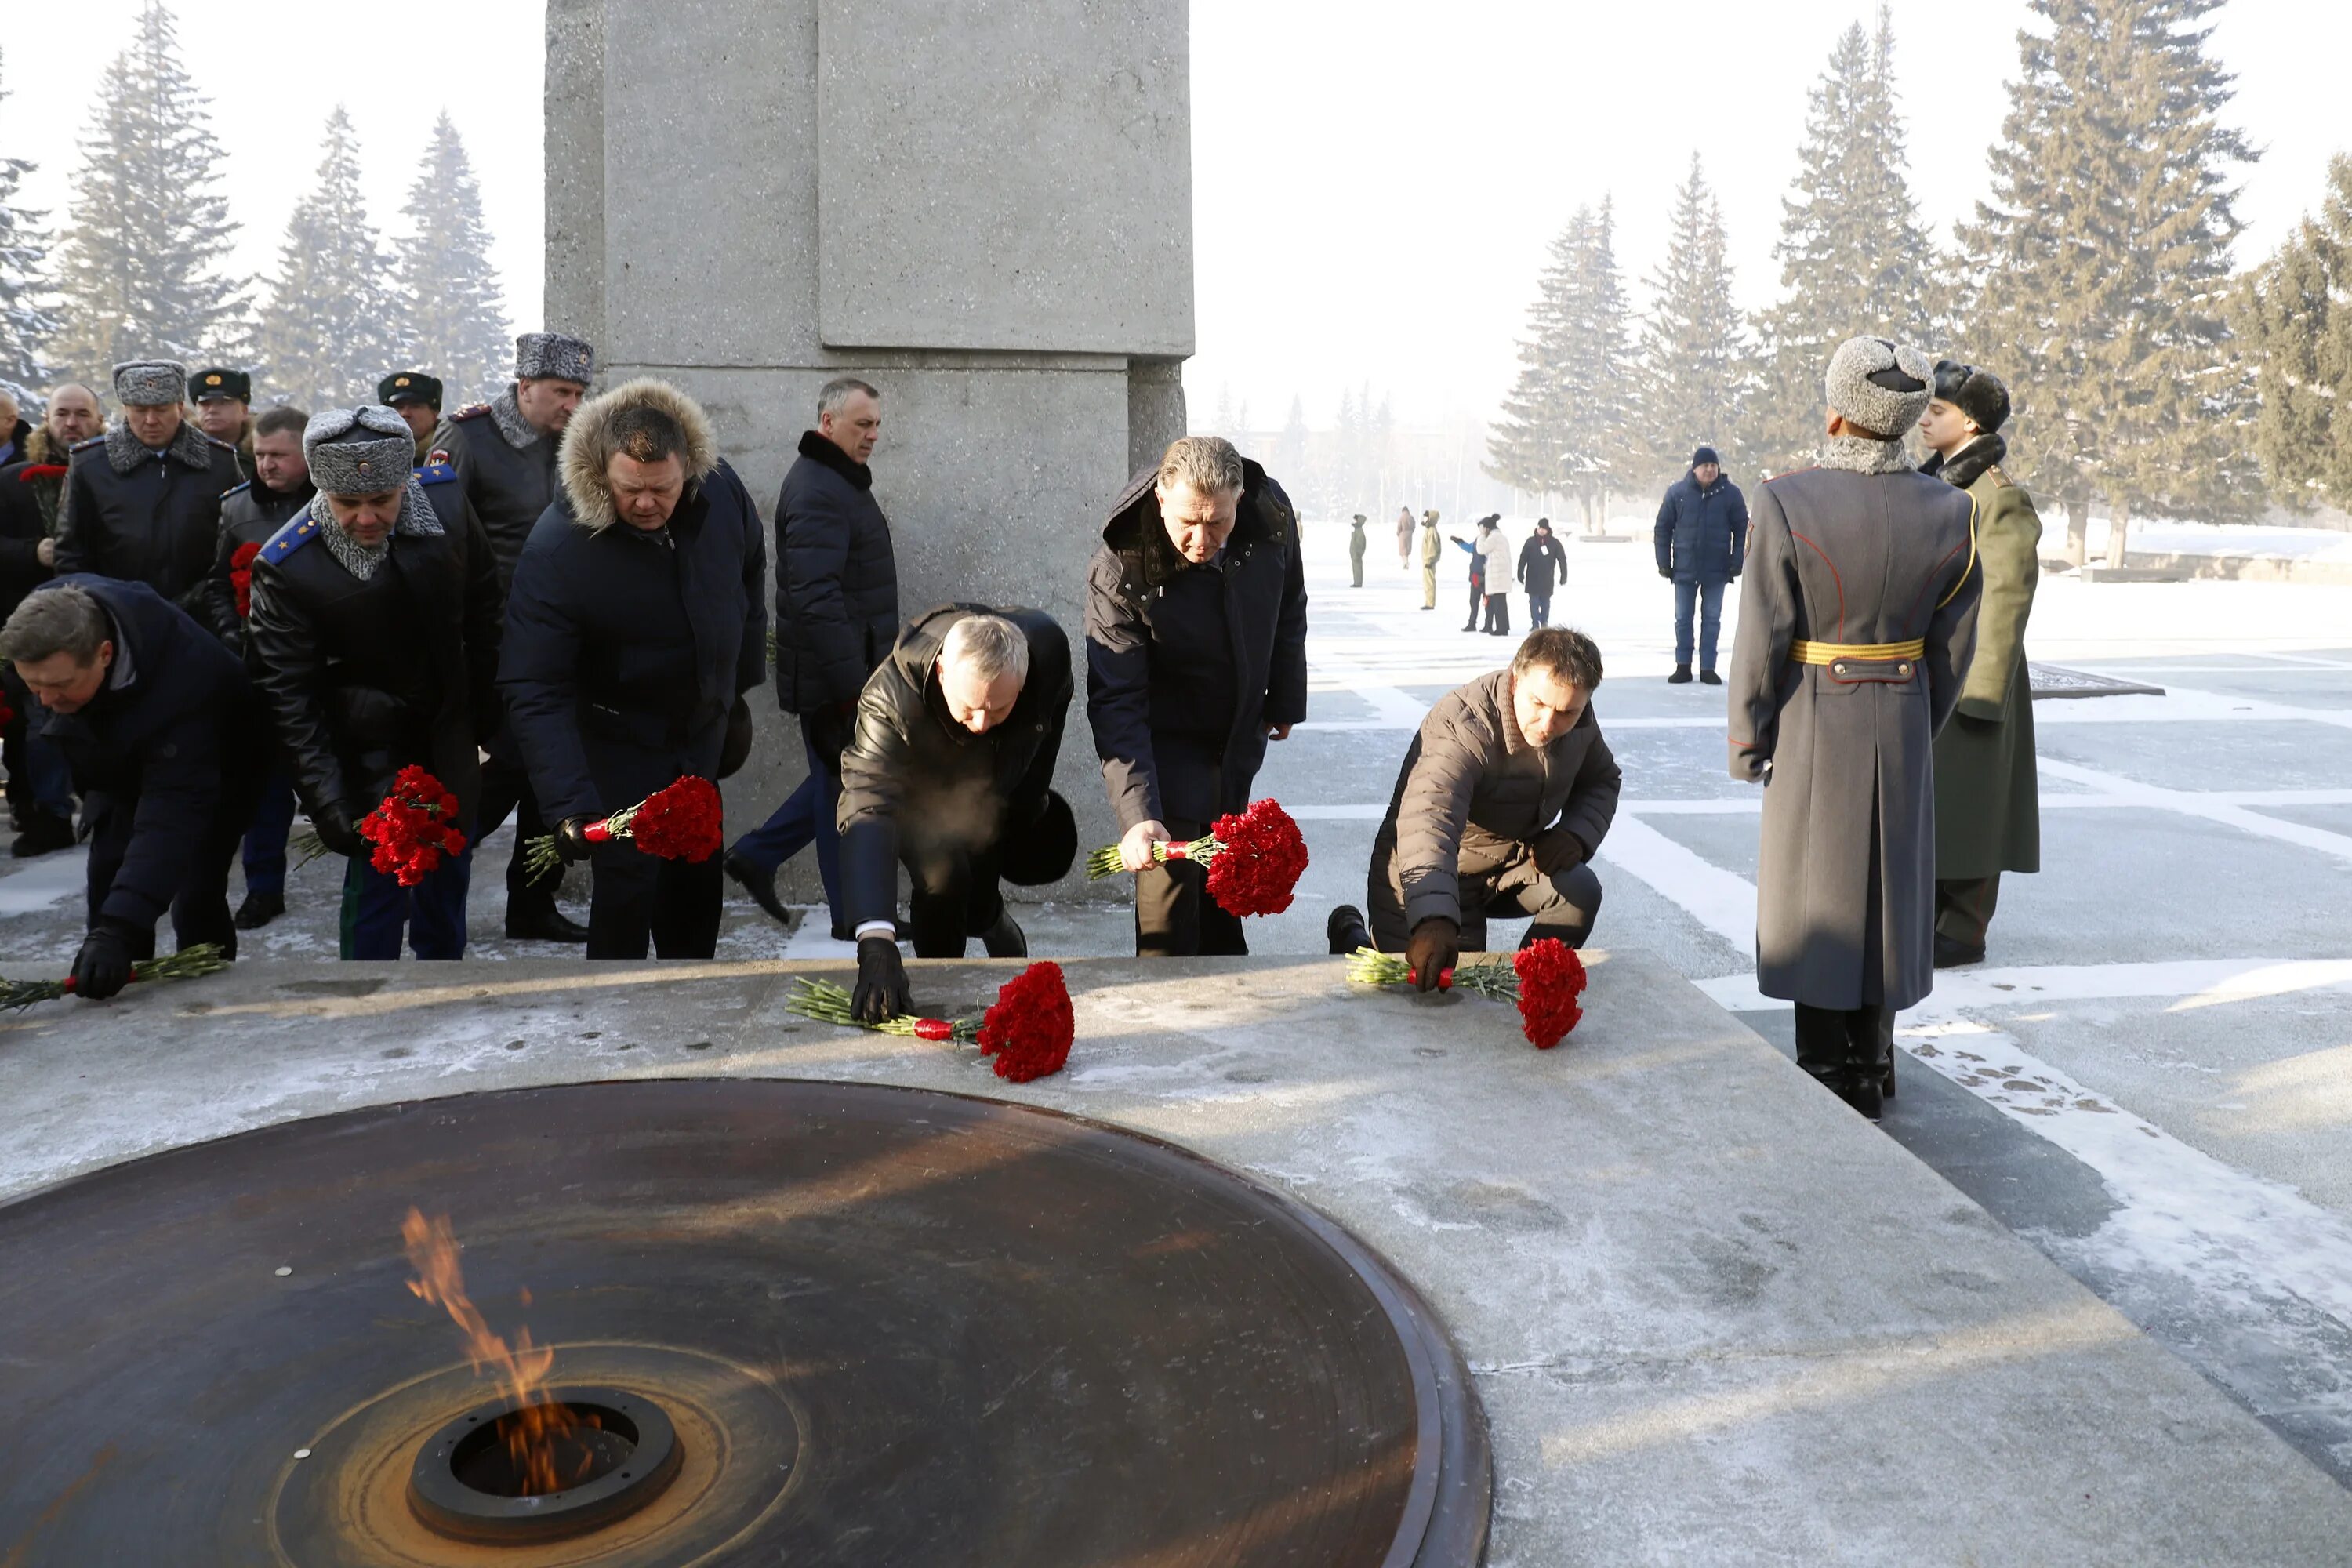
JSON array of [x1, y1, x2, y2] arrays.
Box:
[[45, 0, 245, 386]]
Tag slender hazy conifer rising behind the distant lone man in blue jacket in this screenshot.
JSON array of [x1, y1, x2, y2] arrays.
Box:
[[1635, 153, 1748, 482]]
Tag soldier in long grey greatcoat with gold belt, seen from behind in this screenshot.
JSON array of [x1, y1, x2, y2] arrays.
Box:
[[1729, 339, 1983, 1119]]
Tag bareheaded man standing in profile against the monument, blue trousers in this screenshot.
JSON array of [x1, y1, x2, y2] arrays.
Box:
[[727, 376, 898, 942]]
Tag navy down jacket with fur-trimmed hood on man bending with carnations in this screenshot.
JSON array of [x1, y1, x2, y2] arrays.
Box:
[[499, 379, 767, 822]]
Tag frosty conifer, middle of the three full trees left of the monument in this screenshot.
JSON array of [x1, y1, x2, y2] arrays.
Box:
[[254, 103, 407, 412]]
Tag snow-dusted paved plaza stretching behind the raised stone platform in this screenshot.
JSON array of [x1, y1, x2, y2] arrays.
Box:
[[0, 517, 2352, 1481]]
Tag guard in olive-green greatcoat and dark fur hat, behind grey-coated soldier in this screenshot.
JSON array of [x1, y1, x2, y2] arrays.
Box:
[[1919, 360, 2042, 968]]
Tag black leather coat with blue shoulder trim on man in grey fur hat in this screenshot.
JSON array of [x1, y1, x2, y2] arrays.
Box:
[[247, 470, 503, 837]]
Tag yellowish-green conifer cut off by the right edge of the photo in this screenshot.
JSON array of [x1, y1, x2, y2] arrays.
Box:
[[2239, 153, 2352, 510]]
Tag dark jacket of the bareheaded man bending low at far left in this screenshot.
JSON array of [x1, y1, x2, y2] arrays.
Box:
[[33, 576, 270, 935]]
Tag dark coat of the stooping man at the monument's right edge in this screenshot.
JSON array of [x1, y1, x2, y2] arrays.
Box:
[[1087, 459, 1308, 829]]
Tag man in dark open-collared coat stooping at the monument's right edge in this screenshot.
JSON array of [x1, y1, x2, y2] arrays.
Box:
[[1087, 435, 1308, 956]]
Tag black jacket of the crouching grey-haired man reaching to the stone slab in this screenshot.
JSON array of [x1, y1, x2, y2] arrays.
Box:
[[837, 604, 1073, 926]]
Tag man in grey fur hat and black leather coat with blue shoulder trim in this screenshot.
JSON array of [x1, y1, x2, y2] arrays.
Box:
[[249, 407, 503, 959]]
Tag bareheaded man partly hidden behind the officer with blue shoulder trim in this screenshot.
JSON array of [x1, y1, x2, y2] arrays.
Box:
[[202, 407, 313, 931]]
